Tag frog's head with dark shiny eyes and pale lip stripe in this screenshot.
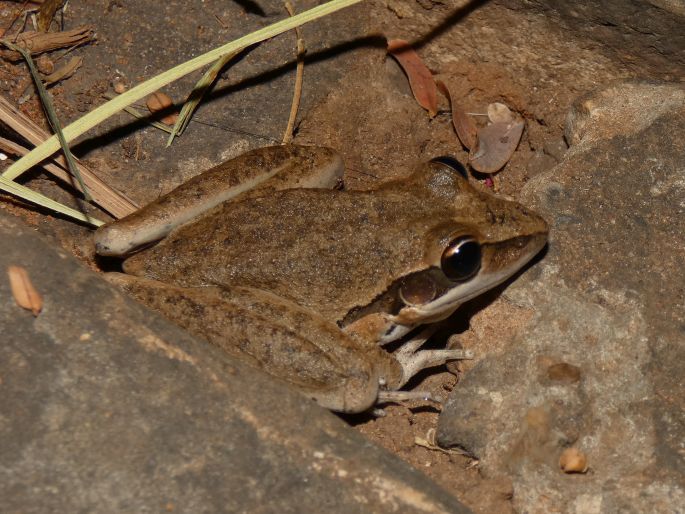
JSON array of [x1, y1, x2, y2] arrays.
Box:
[[344, 158, 548, 344]]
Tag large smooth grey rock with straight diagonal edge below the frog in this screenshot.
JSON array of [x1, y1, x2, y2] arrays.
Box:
[[0, 211, 468, 513]]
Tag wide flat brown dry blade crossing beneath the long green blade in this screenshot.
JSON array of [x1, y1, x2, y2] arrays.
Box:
[[0, 96, 138, 218]]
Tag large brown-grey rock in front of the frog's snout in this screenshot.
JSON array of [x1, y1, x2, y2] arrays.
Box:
[[437, 82, 685, 512]]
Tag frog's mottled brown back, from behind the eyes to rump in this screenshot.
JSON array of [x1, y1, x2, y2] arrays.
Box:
[[125, 189, 431, 320]]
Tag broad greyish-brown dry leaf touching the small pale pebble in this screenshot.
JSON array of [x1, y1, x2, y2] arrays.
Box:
[[469, 120, 525, 173]]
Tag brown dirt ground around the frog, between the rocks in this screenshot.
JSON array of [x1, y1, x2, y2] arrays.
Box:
[[0, 0, 652, 513]]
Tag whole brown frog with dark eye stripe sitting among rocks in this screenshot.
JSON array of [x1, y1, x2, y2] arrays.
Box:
[[94, 145, 548, 413]]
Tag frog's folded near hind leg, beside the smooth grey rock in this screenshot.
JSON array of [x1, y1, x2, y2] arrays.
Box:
[[105, 274, 379, 412]]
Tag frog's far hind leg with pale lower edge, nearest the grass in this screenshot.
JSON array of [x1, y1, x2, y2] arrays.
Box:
[[95, 145, 343, 255]]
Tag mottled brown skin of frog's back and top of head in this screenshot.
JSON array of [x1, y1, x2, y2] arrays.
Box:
[[124, 165, 546, 322]]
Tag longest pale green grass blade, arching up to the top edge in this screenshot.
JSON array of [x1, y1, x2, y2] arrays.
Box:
[[3, 0, 361, 179]]
